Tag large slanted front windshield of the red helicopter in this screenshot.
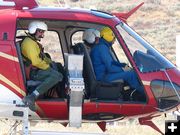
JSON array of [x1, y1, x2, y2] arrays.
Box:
[[116, 22, 174, 72]]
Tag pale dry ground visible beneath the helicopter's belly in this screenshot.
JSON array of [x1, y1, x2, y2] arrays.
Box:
[[0, 115, 175, 135]]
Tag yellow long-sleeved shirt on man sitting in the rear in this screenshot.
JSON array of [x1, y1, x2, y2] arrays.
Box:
[[21, 37, 49, 70]]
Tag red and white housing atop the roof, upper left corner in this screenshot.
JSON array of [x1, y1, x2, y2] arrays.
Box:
[[0, 0, 38, 10]]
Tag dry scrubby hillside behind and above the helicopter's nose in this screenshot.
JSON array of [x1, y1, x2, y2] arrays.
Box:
[[39, 0, 180, 63]]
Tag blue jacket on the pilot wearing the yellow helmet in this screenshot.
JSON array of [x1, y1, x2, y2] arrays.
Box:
[[90, 38, 125, 81]]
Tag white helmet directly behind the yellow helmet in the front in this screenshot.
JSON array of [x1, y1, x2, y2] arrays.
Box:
[[83, 29, 100, 44]]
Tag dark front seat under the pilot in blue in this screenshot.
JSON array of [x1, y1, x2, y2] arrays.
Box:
[[73, 43, 124, 100]]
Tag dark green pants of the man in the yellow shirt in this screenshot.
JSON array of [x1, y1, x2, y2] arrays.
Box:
[[31, 68, 63, 95]]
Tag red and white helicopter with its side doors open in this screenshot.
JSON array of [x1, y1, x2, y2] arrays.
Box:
[[0, 0, 180, 134]]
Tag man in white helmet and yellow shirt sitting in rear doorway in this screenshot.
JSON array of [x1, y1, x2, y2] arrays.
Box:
[[21, 21, 63, 111]]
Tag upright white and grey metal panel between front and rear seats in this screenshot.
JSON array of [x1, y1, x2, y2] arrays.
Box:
[[65, 54, 84, 127]]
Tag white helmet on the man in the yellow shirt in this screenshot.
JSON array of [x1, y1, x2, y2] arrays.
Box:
[[28, 21, 48, 34]]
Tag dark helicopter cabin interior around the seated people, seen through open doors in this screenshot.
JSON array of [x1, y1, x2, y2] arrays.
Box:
[[16, 19, 146, 103]]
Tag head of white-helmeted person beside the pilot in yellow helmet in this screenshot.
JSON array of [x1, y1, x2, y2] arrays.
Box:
[[83, 29, 100, 47]]
